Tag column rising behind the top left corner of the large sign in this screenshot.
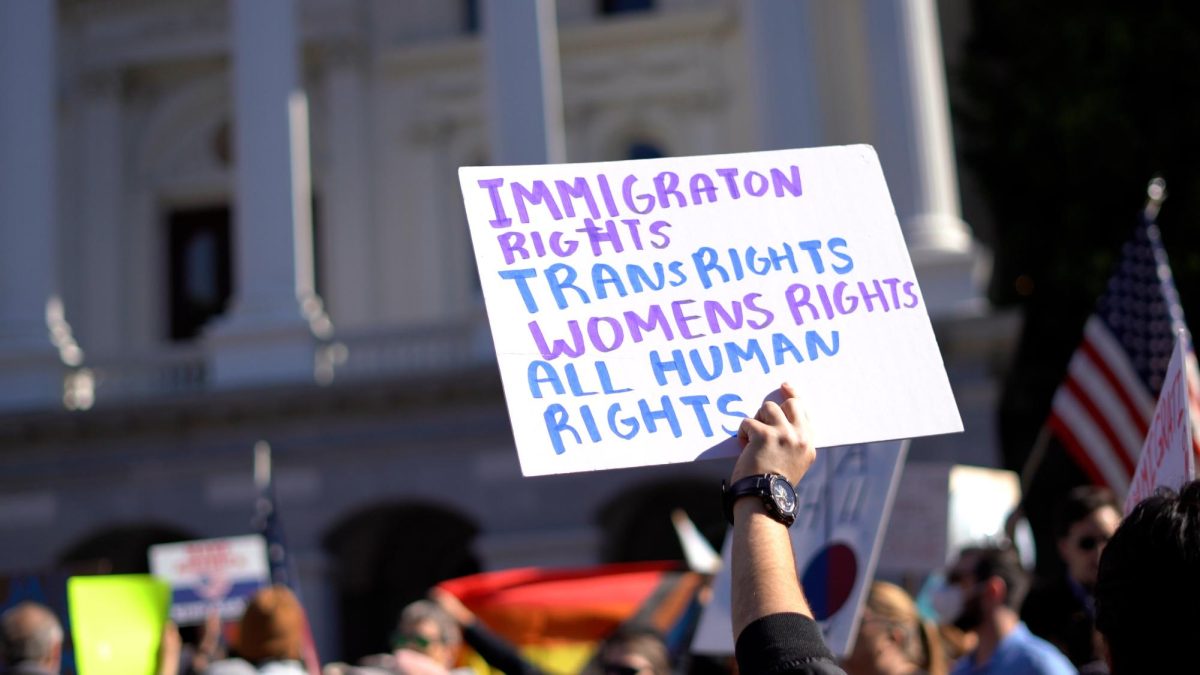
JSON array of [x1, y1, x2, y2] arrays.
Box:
[[481, 0, 566, 165]]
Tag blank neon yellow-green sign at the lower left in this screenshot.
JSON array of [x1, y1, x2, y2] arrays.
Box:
[[67, 574, 170, 675]]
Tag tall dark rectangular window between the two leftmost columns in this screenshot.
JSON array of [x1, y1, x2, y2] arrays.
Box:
[[167, 205, 233, 341]]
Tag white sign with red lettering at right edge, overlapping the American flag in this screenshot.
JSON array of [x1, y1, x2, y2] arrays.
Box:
[[1124, 330, 1196, 515]]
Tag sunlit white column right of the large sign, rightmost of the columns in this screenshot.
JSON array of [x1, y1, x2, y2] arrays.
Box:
[[866, 0, 978, 313]]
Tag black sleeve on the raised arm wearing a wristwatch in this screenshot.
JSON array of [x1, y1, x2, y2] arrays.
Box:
[[734, 614, 845, 675]]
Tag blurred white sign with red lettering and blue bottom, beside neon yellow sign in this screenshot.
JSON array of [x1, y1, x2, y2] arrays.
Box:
[[150, 534, 270, 626]]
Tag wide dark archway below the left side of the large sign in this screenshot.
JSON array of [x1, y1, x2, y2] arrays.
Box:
[[324, 503, 480, 663]]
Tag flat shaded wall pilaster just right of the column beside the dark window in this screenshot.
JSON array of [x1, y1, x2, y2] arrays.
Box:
[[320, 44, 377, 330]]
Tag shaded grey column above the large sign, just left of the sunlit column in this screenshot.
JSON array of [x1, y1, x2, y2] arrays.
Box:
[[740, 0, 822, 150]]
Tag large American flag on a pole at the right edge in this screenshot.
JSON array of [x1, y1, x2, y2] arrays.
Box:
[[1048, 208, 1200, 495]]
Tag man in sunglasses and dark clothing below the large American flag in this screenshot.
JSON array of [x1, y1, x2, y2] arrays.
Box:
[[1021, 485, 1121, 668]]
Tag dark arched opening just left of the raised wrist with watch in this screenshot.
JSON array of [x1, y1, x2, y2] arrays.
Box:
[[599, 479, 727, 562]]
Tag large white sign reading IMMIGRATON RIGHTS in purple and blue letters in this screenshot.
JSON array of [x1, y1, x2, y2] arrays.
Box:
[[458, 145, 962, 476]]
